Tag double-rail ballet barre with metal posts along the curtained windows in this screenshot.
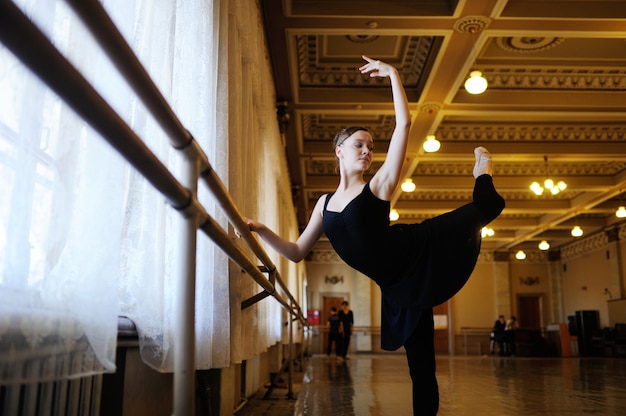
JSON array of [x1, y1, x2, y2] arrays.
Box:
[[0, 0, 307, 415]]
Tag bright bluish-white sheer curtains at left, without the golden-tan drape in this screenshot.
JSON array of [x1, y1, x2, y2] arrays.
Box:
[[0, 0, 223, 383]]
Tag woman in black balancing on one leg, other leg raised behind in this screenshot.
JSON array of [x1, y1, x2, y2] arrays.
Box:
[[246, 56, 505, 415]]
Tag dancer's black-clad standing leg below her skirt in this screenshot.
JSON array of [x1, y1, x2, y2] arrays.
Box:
[[404, 308, 439, 416]]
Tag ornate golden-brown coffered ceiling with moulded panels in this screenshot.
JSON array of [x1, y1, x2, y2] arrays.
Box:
[[261, 0, 626, 251]]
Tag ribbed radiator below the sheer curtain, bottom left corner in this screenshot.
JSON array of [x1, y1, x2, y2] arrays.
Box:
[[0, 374, 102, 416]]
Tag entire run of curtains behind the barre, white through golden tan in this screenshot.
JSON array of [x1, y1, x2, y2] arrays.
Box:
[[0, 0, 297, 383]]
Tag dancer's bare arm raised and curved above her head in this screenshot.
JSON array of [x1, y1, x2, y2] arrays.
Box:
[[359, 56, 411, 201]]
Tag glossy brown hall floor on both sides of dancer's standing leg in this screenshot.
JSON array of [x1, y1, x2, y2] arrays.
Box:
[[293, 354, 626, 416]]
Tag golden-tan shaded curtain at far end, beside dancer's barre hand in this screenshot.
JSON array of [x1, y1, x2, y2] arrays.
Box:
[[222, 0, 288, 362]]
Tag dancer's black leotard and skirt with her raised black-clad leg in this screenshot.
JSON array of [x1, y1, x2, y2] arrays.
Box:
[[323, 175, 504, 349]]
